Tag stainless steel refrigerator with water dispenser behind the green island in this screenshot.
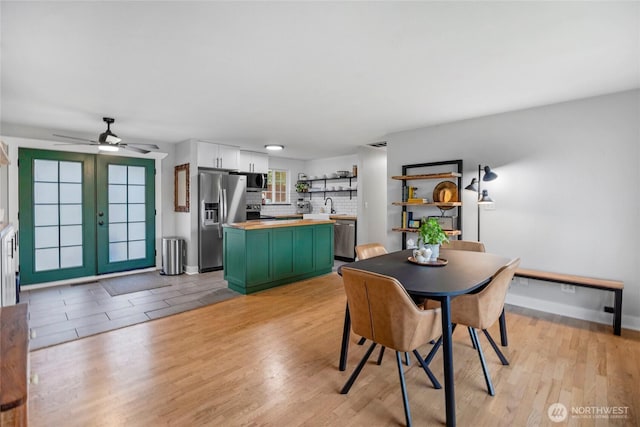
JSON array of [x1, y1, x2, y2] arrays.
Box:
[[198, 171, 247, 273]]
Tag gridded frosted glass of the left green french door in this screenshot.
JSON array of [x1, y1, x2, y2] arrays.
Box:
[[33, 159, 83, 271]]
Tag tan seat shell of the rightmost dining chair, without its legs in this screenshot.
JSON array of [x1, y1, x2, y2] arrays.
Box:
[[451, 258, 520, 329]]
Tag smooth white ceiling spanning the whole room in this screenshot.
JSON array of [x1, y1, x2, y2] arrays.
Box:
[[0, 1, 640, 159]]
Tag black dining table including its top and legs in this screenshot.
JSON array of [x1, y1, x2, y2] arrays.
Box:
[[339, 249, 510, 426]]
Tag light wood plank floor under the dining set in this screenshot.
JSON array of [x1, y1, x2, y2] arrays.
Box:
[[29, 273, 640, 426]]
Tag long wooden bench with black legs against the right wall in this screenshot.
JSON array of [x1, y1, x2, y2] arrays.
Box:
[[515, 268, 624, 335]]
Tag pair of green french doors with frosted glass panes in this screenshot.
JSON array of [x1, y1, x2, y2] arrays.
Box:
[[18, 148, 155, 285]]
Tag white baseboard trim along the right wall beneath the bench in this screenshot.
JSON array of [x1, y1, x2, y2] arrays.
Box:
[[505, 294, 640, 331]]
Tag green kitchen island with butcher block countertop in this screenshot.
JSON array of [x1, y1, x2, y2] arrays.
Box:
[[223, 219, 335, 294]]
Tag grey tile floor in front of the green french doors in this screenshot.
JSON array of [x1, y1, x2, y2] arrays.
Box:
[[20, 271, 232, 350]]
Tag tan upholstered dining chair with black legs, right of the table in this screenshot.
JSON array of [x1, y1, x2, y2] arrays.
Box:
[[425, 258, 520, 396]]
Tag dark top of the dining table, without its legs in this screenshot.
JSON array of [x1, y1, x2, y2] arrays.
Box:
[[342, 249, 510, 297]]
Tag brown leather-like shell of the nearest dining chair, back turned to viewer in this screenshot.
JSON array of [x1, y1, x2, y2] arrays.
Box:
[[342, 267, 442, 351]]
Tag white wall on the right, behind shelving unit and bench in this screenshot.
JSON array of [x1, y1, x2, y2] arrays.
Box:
[[387, 90, 640, 329]]
